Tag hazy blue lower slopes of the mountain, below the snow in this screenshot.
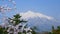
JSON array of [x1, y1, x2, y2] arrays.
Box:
[[28, 17, 60, 31]]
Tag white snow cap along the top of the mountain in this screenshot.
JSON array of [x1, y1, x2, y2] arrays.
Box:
[[20, 11, 53, 20]]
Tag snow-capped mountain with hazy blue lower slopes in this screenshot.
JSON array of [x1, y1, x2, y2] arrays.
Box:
[[20, 11, 60, 31]]
